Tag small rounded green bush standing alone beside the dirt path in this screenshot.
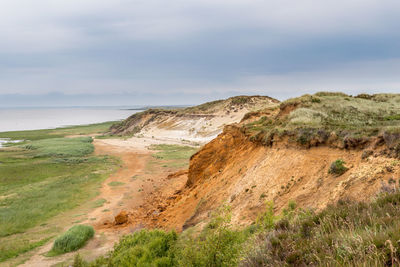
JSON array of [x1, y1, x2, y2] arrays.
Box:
[[49, 225, 94, 256]]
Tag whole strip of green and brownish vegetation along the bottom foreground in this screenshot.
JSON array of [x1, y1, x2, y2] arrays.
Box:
[[74, 188, 400, 267]]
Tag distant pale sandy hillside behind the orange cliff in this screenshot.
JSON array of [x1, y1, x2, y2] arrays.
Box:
[[110, 96, 279, 143]]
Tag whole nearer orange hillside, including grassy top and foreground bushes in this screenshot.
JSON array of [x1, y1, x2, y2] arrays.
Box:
[[74, 93, 400, 267]]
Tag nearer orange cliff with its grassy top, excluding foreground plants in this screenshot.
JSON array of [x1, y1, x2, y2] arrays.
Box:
[[155, 93, 400, 229]]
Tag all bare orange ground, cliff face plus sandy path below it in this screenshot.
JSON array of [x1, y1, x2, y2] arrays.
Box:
[[18, 131, 400, 266]]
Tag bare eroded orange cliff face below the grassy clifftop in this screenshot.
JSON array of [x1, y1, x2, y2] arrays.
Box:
[[170, 126, 400, 228]]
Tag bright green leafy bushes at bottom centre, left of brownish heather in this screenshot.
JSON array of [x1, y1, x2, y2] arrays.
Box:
[[74, 206, 247, 267]]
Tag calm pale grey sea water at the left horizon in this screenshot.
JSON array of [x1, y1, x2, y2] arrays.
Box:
[[0, 107, 139, 132]]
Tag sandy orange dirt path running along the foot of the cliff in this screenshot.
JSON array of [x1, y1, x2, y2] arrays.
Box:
[[20, 138, 191, 267]]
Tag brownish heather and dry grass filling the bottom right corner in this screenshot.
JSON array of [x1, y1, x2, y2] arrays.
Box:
[[239, 191, 400, 267]]
